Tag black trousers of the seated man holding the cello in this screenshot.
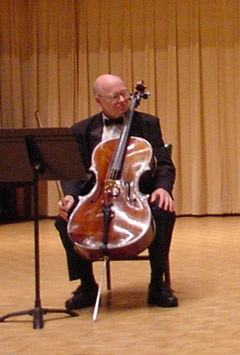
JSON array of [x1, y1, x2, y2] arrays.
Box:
[[55, 205, 176, 284]]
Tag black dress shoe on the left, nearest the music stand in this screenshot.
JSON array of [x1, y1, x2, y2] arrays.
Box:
[[65, 284, 98, 309]]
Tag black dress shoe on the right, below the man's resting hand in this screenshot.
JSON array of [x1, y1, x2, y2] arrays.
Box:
[[148, 282, 178, 307]]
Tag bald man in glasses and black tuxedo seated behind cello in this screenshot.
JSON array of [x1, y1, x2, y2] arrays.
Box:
[[56, 74, 178, 309]]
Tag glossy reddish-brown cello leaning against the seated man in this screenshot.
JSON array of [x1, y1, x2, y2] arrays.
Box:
[[67, 82, 155, 261]]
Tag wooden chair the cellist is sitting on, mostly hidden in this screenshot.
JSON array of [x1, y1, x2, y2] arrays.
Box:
[[106, 143, 172, 290]]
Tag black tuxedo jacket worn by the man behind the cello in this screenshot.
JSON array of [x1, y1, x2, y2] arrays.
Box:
[[62, 111, 175, 197]]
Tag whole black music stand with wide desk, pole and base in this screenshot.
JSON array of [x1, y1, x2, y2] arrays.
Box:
[[0, 128, 86, 329]]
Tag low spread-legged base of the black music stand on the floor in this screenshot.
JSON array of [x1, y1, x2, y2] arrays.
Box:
[[0, 307, 78, 329]]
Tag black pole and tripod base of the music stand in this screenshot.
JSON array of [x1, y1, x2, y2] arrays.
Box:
[[0, 136, 78, 329]]
